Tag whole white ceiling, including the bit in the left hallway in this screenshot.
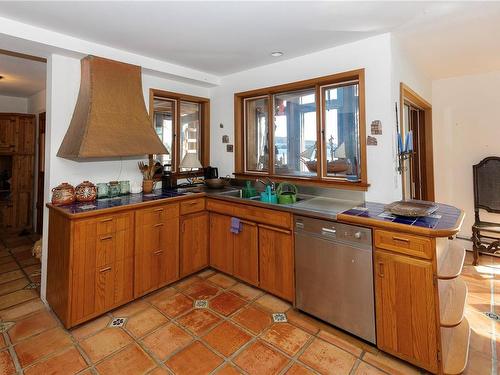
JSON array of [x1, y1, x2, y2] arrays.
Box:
[[0, 1, 500, 83]]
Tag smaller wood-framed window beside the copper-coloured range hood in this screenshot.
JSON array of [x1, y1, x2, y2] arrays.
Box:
[[150, 89, 210, 174]]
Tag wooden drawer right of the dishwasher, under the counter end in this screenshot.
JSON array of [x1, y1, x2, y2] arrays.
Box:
[[375, 230, 433, 259]]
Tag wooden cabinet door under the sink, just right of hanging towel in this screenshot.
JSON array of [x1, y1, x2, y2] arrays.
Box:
[[233, 221, 259, 286]]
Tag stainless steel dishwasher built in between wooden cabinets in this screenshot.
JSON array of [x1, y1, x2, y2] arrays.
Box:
[[295, 216, 376, 343]]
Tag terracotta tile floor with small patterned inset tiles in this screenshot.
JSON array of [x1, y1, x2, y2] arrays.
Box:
[[0, 232, 500, 375]]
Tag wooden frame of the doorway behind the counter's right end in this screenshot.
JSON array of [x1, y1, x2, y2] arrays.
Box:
[[399, 82, 435, 201]]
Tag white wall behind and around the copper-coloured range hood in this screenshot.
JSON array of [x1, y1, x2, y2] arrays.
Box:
[[42, 54, 210, 298]]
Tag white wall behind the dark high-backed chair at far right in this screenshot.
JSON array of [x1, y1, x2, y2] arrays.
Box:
[[432, 71, 500, 237]]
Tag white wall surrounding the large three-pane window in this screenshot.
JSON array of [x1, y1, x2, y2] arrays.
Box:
[[210, 34, 401, 202]]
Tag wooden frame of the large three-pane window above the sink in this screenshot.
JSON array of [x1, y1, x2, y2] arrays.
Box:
[[234, 69, 370, 191]]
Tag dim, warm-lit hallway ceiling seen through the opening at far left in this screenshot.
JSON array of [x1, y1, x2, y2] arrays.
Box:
[[0, 53, 46, 98]]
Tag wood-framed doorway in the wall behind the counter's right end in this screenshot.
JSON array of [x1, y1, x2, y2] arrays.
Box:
[[400, 83, 434, 201]]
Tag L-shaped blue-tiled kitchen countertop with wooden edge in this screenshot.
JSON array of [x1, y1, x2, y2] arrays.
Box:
[[47, 186, 464, 237]]
